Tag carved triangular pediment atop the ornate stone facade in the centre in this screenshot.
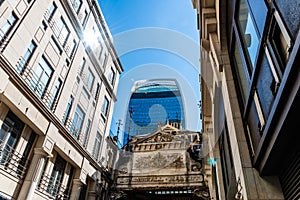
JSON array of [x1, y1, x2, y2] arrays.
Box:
[[130, 124, 178, 145]]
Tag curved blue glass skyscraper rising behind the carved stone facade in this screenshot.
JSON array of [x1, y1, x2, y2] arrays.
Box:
[[123, 79, 185, 145]]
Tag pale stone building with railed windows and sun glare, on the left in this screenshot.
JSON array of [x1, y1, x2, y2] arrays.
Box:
[[0, 0, 123, 200]]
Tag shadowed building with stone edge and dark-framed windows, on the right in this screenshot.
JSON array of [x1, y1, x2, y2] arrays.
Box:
[[192, 0, 300, 200]]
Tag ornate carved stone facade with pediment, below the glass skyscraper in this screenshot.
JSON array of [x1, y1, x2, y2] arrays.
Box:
[[112, 123, 209, 200]]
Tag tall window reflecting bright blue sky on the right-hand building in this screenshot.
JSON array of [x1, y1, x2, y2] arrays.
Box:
[[238, 0, 259, 75]]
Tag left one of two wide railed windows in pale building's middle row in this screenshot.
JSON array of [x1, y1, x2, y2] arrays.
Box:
[[30, 57, 53, 97]]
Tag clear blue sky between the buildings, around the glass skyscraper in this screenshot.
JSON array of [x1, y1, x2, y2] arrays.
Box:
[[99, 0, 201, 143]]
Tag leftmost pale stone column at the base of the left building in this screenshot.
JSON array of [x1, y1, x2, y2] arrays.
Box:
[[18, 148, 48, 200]]
